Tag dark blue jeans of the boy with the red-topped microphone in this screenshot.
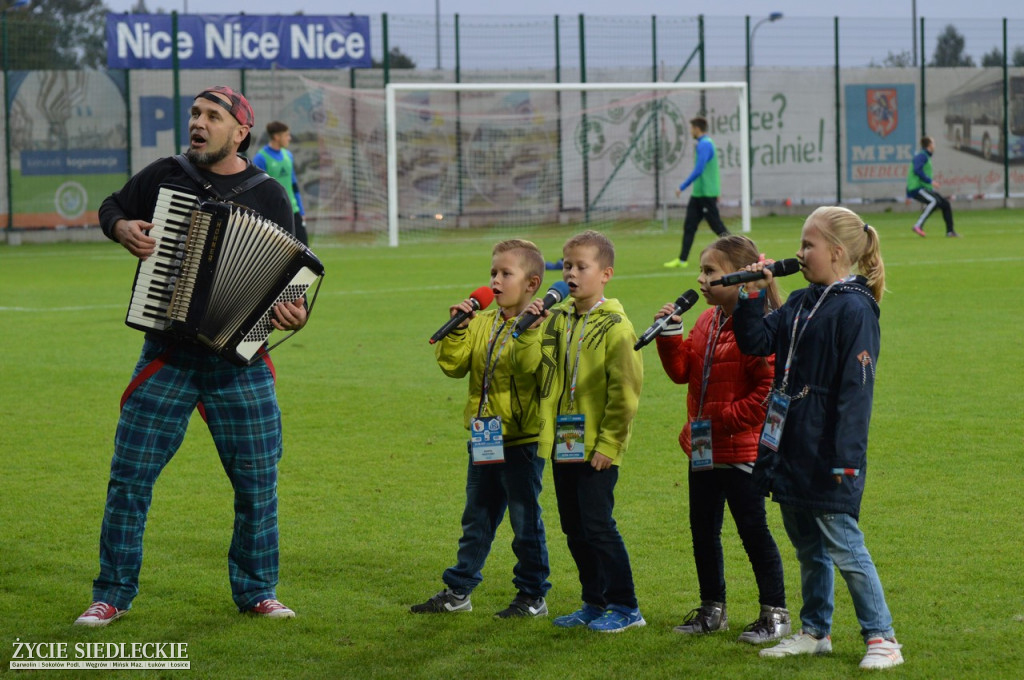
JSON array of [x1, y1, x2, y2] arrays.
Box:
[[441, 443, 551, 597]]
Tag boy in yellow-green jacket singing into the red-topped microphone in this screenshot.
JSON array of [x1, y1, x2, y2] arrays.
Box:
[[411, 239, 551, 619]]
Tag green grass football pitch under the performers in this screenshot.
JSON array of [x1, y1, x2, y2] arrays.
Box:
[[0, 211, 1024, 680]]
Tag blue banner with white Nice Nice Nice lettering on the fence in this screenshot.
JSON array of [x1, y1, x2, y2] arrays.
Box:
[[106, 13, 371, 69]]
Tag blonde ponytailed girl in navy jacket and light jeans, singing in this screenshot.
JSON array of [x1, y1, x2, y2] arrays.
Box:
[[733, 207, 903, 669]]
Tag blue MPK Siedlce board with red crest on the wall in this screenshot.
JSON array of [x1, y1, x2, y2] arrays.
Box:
[[846, 85, 918, 182]]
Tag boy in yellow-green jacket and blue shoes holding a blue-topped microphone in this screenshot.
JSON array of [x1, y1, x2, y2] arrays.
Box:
[[512, 230, 646, 633]]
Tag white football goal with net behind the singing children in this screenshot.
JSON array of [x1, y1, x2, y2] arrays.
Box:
[[385, 82, 751, 246]]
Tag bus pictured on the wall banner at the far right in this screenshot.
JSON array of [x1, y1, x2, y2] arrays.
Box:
[[945, 73, 1024, 163]]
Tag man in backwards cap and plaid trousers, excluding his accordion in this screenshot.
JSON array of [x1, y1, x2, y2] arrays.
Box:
[[75, 86, 307, 626]]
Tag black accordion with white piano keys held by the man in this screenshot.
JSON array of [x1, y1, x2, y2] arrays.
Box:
[[125, 185, 324, 366]]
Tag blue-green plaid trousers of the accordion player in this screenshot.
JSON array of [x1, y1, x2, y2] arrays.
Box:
[[92, 337, 282, 610]]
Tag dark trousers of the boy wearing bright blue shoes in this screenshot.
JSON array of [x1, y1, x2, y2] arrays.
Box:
[[552, 463, 637, 610]]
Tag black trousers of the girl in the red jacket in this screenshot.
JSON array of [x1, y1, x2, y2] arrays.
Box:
[[689, 467, 785, 607]]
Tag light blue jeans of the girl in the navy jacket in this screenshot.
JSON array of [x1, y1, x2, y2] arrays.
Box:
[[780, 505, 895, 641]]
